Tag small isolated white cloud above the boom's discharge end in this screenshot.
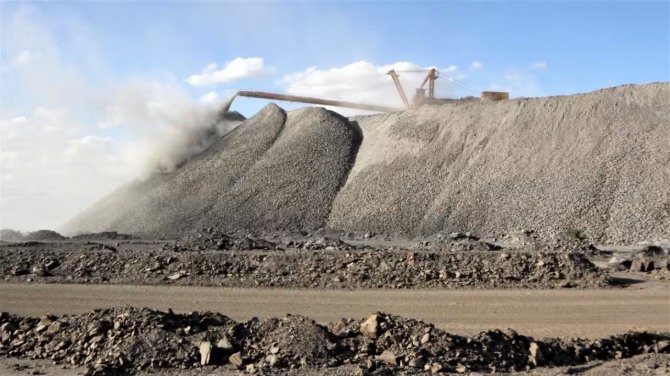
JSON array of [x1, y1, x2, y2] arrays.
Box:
[[186, 57, 276, 87]]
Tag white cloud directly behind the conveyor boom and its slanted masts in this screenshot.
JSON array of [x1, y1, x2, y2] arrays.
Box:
[[277, 61, 468, 116]]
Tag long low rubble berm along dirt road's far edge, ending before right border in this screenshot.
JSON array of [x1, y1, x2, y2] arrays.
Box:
[[0, 244, 610, 289]]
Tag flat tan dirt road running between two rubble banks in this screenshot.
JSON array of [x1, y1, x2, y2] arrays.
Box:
[[0, 284, 670, 338]]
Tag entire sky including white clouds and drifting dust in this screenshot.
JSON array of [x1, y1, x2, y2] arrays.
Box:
[[0, 0, 670, 229]]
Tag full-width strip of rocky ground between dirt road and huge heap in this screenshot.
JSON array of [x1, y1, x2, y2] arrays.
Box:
[[0, 228, 670, 289]]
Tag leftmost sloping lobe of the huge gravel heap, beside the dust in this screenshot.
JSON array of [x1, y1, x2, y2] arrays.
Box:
[[64, 105, 286, 237]]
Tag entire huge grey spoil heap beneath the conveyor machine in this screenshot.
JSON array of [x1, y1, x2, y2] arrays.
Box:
[[64, 83, 670, 244]]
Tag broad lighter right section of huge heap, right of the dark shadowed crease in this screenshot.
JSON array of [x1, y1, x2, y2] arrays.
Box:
[[329, 82, 670, 244]]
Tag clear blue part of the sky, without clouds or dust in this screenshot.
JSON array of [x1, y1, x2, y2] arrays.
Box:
[[1, 1, 670, 115]]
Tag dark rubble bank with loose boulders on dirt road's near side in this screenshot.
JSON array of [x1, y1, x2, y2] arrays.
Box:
[[0, 307, 670, 375]]
